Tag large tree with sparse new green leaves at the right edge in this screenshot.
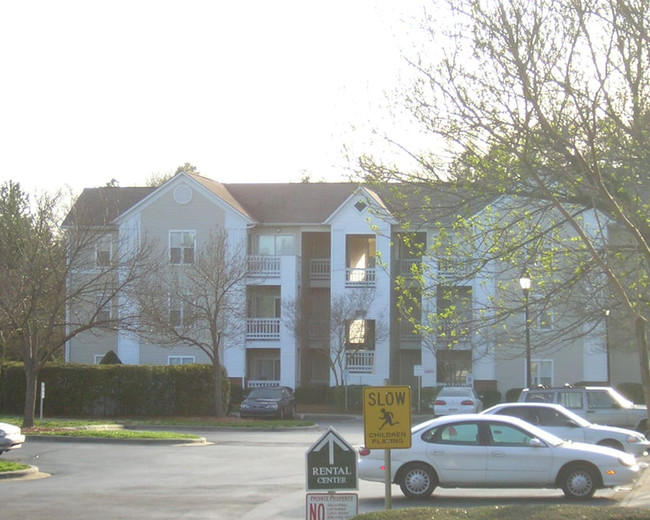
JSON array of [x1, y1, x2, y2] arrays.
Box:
[[361, 0, 650, 402]]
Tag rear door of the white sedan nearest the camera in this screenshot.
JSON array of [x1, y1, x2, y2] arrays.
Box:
[[422, 421, 487, 486]]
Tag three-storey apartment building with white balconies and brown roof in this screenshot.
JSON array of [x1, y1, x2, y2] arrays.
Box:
[[65, 172, 608, 393]]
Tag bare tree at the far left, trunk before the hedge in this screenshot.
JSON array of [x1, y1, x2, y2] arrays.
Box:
[[0, 183, 154, 427]]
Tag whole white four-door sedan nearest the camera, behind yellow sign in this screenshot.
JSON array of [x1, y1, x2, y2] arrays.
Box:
[[358, 414, 640, 499]]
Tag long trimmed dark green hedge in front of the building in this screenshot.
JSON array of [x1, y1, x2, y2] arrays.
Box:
[[0, 364, 230, 417]]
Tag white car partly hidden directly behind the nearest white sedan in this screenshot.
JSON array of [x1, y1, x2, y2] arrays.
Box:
[[481, 402, 650, 457]]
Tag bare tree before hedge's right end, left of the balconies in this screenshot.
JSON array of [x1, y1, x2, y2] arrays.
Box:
[[137, 234, 248, 417]]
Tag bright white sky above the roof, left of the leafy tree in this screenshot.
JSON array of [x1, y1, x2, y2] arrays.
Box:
[[0, 0, 425, 196]]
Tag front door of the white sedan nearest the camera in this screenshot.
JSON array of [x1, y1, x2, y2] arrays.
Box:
[[485, 422, 553, 487]]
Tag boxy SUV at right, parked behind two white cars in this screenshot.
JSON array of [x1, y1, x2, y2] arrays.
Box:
[[519, 385, 648, 434]]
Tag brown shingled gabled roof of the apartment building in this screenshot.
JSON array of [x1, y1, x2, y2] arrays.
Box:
[[64, 172, 488, 226]]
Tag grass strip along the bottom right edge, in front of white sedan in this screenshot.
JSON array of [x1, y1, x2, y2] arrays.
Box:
[[353, 504, 650, 520]]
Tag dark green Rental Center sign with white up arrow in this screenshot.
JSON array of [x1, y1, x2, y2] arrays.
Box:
[[306, 427, 359, 491]]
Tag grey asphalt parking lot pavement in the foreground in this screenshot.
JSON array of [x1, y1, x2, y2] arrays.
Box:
[[0, 419, 625, 520]]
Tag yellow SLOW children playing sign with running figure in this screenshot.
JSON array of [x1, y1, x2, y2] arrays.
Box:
[[363, 386, 411, 449]]
